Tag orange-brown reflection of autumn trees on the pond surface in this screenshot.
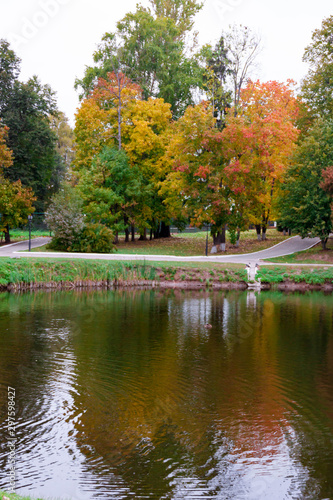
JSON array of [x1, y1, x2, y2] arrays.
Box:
[[66, 293, 332, 495]]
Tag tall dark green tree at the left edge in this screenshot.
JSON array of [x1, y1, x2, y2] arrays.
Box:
[[0, 40, 60, 211]]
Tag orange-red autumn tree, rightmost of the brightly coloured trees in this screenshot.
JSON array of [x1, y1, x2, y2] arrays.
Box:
[[223, 81, 298, 239]]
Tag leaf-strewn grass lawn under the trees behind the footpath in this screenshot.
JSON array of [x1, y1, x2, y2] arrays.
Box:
[[27, 229, 288, 257]]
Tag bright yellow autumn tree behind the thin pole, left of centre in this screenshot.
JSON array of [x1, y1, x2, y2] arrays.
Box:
[[75, 74, 171, 238]]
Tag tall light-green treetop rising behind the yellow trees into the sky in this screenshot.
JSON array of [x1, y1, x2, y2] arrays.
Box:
[[75, 0, 202, 117]]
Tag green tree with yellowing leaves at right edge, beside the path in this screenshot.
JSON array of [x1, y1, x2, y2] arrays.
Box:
[[279, 119, 333, 248]]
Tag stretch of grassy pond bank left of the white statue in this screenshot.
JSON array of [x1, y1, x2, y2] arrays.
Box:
[[0, 258, 247, 288]]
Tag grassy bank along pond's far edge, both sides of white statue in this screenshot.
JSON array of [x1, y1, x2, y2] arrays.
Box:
[[0, 257, 333, 290]]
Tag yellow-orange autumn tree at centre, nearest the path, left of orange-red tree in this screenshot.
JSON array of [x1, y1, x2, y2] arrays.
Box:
[[161, 103, 235, 252]]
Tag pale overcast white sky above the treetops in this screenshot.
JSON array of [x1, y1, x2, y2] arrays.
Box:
[[0, 0, 333, 123]]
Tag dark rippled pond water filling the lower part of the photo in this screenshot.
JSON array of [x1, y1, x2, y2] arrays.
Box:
[[0, 290, 333, 500]]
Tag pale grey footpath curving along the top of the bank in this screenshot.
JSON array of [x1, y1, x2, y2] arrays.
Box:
[[0, 236, 329, 266]]
